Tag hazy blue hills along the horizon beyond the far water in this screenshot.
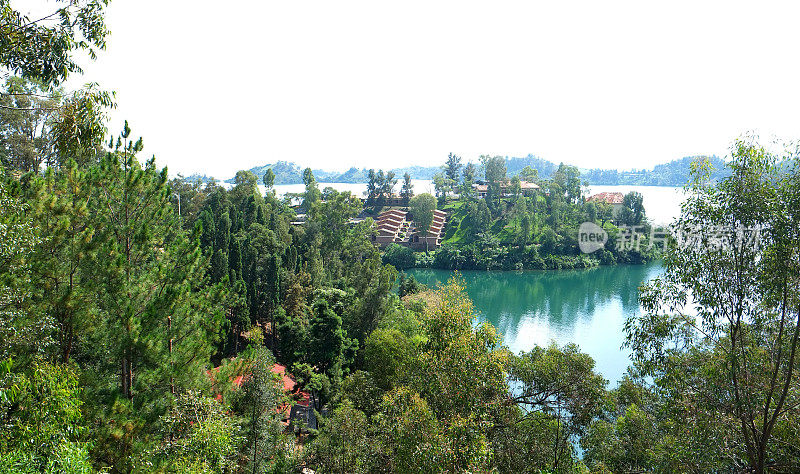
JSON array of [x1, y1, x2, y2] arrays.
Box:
[[216, 155, 726, 186]]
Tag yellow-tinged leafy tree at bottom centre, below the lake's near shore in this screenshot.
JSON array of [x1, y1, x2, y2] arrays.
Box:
[[409, 279, 508, 471]]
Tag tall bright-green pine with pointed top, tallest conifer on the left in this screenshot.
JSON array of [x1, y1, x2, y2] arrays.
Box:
[[93, 123, 222, 403]]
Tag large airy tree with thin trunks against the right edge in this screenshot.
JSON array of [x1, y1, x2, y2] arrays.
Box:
[[626, 139, 800, 472]]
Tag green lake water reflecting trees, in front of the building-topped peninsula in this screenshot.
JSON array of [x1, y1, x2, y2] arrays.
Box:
[[406, 262, 663, 387]]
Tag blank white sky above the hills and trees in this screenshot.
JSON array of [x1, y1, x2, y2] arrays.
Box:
[[16, 0, 800, 177]]
